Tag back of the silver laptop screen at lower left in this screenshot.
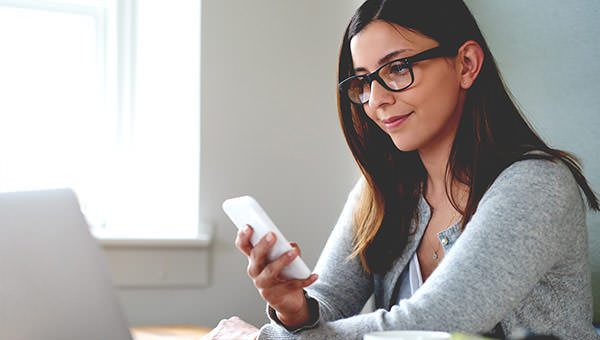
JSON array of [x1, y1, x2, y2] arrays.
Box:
[[0, 189, 131, 340]]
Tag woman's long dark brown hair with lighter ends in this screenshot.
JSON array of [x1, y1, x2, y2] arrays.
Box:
[[338, 0, 598, 273]]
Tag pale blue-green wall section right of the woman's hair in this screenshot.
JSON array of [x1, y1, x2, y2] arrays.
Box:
[[466, 0, 600, 322]]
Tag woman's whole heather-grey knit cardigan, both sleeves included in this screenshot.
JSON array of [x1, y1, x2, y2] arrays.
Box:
[[258, 160, 600, 340]]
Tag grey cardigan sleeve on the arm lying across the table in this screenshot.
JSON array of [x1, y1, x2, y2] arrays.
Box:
[[259, 160, 585, 340]]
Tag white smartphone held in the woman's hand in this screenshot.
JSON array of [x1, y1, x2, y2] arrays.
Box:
[[223, 196, 310, 279]]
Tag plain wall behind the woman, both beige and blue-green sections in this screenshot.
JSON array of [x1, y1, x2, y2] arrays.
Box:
[[113, 0, 600, 326]]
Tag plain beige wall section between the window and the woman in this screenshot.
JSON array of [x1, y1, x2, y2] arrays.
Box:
[[120, 0, 358, 326]]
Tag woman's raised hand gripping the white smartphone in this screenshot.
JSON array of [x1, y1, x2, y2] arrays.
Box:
[[235, 226, 317, 327]]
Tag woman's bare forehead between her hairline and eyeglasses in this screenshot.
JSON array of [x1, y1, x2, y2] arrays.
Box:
[[350, 20, 437, 71]]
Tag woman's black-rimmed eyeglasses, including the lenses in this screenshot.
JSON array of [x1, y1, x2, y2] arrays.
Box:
[[338, 46, 456, 104]]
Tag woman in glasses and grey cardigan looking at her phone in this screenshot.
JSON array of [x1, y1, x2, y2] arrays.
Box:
[[207, 0, 600, 340]]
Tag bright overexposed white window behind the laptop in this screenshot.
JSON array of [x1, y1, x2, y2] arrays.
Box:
[[0, 0, 200, 238]]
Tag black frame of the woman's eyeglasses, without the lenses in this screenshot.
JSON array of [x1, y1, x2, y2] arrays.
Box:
[[338, 46, 457, 105]]
